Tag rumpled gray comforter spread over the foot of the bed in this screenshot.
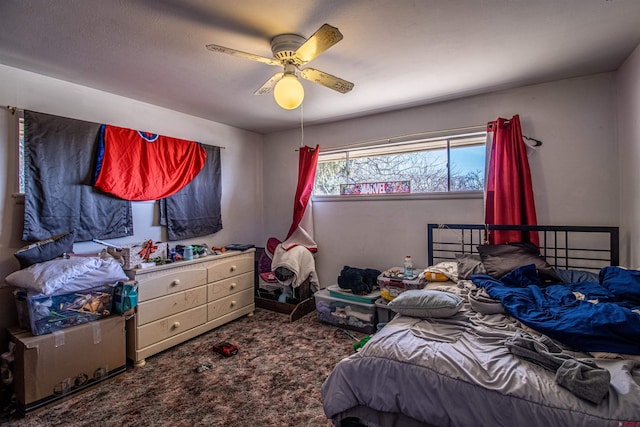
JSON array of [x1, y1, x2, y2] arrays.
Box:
[[322, 281, 640, 426]]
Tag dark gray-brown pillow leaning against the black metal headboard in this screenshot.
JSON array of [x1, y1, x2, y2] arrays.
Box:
[[478, 242, 562, 283]]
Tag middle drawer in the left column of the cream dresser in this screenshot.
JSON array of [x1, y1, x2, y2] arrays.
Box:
[[136, 286, 207, 325]]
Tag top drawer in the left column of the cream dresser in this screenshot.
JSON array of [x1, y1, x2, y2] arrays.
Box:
[[136, 264, 207, 302]]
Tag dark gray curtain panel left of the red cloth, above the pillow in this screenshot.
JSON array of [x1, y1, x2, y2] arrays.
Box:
[[22, 111, 133, 242]]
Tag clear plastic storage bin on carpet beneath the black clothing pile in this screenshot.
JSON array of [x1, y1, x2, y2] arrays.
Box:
[[314, 289, 377, 334]]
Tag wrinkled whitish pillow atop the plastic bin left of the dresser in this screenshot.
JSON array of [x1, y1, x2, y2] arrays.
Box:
[[5, 257, 128, 296]]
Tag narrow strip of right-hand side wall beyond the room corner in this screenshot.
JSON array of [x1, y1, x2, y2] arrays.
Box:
[[617, 45, 640, 268]]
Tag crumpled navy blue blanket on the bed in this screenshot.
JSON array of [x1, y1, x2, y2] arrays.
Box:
[[471, 265, 640, 354]]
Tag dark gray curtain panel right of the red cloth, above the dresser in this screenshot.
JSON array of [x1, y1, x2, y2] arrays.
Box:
[[160, 144, 222, 241]]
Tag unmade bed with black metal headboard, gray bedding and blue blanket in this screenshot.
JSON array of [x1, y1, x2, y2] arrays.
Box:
[[322, 224, 640, 427]]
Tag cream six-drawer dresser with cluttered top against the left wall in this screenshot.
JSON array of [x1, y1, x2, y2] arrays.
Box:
[[127, 249, 255, 366]]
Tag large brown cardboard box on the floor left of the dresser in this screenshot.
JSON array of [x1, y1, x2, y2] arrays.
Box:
[[9, 316, 126, 414]]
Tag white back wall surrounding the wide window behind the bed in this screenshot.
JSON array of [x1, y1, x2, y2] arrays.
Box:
[[264, 73, 620, 286]]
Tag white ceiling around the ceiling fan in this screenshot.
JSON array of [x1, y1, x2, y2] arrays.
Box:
[[0, 0, 640, 133]]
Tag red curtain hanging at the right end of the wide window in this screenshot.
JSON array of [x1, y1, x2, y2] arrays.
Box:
[[484, 114, 539, 246]]
